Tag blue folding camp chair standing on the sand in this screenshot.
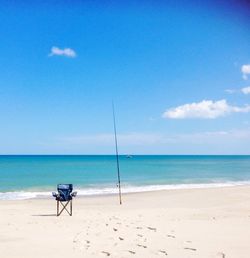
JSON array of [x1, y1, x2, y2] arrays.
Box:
[[52, 184, 77, 216]]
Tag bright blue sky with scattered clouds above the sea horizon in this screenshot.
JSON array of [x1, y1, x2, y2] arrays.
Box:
[[0, 0, 250, 155]]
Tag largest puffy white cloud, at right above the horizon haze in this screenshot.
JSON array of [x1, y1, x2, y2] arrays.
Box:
[[163, 99, 250, 119]]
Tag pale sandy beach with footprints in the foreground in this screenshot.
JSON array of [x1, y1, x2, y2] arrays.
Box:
[[0, 186, 250, 258]]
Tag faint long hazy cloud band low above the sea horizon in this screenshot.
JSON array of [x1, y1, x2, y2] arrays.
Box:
[[58, 130, 250, 146]]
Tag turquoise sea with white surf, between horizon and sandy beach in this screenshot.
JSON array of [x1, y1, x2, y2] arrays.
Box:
[[0, 155, 250, 199]]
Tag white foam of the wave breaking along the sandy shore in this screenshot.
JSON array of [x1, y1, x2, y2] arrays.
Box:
[[0, 181, 250, 200]]
